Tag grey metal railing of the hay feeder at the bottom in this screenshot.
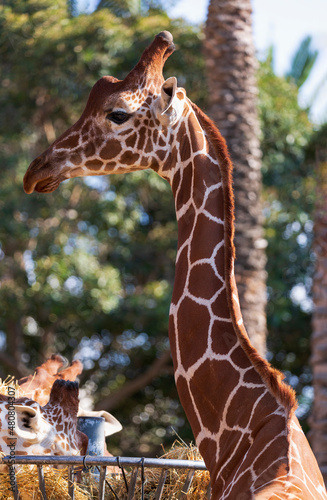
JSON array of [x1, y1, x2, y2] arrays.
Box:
[[1, 455, 210, 500]]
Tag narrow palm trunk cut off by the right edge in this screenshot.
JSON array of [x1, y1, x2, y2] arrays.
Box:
[[310, 134, 327, 484]]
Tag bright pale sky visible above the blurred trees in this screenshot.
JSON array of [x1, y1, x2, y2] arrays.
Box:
[[169, 0, 327, 123]]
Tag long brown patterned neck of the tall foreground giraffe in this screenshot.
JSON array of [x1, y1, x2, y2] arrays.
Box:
[[165, 105, 294, 491]]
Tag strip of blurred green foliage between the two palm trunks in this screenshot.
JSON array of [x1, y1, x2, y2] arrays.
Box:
[[258, 44, 315, 426]]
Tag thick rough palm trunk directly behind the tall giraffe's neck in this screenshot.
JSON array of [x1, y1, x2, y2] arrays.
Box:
[[205, 0, 267, 354]]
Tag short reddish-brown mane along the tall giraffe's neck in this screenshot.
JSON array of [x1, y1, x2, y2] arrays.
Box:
[[191, 102, 297, 417]]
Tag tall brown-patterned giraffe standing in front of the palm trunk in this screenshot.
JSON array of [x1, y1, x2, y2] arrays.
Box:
[[24, 31, 327, 500]]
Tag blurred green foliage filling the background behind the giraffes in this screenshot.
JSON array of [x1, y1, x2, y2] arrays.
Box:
[[0, 0, 326, 455]]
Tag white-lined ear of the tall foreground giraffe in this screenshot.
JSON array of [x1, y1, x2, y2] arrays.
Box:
[[153, 76, 184, 127]]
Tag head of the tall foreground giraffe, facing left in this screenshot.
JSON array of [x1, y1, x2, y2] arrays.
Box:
[[24, 31, 185, 193]]
